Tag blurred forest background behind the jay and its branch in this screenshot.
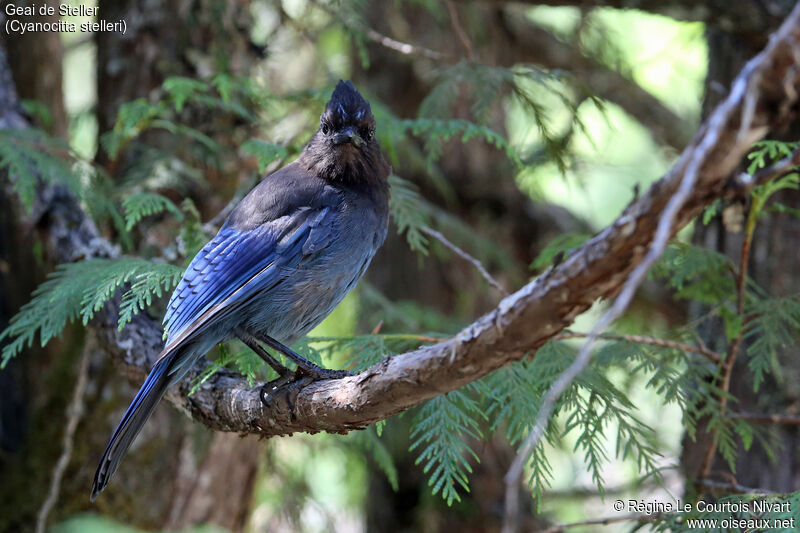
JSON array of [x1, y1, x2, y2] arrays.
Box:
[[0, 0, 800, 533]]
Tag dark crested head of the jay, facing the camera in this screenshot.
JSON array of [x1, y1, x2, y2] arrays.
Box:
[[301, 80, 389, 184]]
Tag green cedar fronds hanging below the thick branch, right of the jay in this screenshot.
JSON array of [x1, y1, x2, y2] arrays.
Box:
[[412, 336, 668, 504]]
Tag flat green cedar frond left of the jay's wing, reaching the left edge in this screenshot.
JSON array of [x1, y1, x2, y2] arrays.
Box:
[[0, 257, 182, 366]]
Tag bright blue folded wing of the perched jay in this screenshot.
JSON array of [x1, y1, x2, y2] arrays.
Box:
[[164, 207, 334, 352]]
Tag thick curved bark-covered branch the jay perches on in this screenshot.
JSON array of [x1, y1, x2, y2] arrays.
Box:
[[0, 7, 800, 436]]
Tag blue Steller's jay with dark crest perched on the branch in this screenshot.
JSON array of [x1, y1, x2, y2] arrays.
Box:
[[91, 81, 389, 501]]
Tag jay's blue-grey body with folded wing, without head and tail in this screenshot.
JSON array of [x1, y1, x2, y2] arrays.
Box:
[[164, 161, 388, 376]]
